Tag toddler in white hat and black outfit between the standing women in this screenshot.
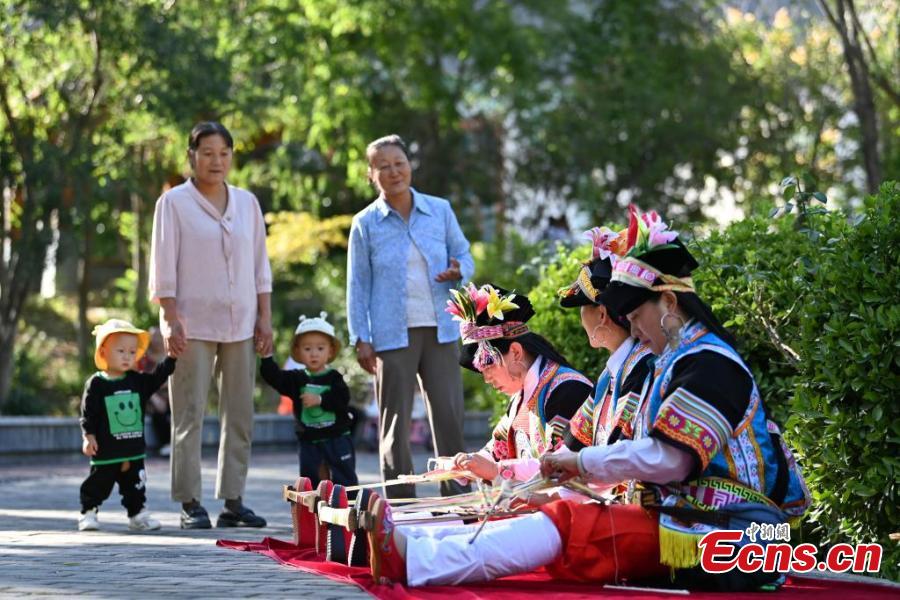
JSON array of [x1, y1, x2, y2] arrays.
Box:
[[260, 312, 358, 487]]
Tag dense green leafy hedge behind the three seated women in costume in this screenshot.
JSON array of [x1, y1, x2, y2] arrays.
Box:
[[529, 183, 900, 579]]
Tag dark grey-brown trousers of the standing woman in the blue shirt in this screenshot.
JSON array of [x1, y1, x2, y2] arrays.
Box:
[[375, 327, 466, 498]]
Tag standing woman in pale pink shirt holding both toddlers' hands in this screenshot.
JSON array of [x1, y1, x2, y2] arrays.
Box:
[[150, 122, 272, 529]]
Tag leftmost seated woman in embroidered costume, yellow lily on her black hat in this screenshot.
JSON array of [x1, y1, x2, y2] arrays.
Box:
[[448, 283, 591, 480]]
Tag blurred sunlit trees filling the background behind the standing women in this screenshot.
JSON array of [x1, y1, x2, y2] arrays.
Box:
[[0, 0, 900, 412]]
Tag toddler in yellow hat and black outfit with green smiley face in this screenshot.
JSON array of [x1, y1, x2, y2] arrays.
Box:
[[78, 319, 175, 531]]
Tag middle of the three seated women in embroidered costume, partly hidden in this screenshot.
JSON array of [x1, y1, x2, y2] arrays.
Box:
[[559, 227, 652, 451]]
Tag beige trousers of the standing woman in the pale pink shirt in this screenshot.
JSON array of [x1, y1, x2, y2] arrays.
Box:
[[169, 338, 256, 502]]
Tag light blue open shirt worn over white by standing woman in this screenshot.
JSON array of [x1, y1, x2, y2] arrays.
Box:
[[347, 189, 475, 352]]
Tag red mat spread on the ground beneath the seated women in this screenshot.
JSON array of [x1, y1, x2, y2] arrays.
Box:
[[216, 538, 900, 600]]
